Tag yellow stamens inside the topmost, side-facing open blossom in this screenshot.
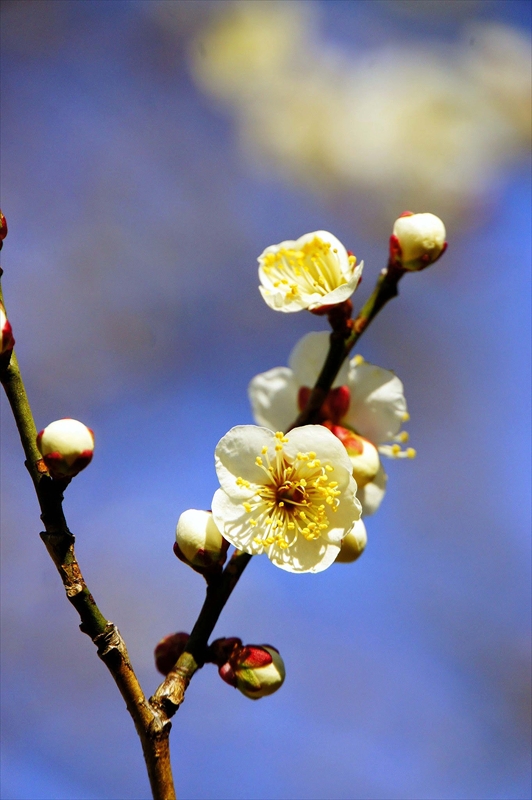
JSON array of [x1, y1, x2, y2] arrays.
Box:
[[261, 236, 356, 300]]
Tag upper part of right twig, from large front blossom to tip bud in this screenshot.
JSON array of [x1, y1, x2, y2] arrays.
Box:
[[288, 262, 405, 430]]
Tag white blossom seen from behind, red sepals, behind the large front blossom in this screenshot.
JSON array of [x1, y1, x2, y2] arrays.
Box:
[[249, 331, 415, 516]]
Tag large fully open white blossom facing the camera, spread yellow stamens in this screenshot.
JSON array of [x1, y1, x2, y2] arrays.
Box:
[[212, 425, 361, 572]]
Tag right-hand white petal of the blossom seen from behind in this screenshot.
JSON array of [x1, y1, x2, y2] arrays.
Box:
[[343, 359, 406, 444]]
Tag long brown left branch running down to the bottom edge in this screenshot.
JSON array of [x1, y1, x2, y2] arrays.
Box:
[[0, 286, 176, 800]]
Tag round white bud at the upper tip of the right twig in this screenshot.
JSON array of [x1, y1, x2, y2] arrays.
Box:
[[390, 211, 447, 272]]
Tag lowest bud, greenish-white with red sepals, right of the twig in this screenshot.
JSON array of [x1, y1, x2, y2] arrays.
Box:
[[218, 644, 285, 700]]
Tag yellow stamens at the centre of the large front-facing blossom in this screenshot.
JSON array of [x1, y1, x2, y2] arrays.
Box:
[[236, 432, 341, 549]]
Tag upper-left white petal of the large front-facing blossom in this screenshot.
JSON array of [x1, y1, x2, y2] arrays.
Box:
[[214, 425, 277, 501]]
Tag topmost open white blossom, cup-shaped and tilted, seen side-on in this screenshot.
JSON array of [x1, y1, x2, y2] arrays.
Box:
[[259, 231, 364, 311]]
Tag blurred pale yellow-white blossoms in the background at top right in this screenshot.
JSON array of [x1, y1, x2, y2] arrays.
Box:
[[190, 0, 531, 221]]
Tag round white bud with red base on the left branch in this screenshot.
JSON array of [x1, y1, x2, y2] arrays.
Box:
[[37, 419, 94, 478]]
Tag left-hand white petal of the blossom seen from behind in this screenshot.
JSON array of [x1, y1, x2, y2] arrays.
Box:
[[248, 367, 299, 431]]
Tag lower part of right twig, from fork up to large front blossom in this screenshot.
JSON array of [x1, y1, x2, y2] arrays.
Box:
[[150, 550, 252, 718]]
